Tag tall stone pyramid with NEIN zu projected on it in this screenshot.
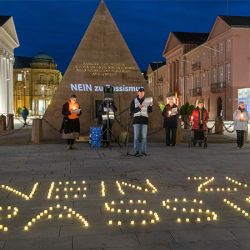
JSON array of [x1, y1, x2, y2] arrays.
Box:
[[42, 0, 162, 140]]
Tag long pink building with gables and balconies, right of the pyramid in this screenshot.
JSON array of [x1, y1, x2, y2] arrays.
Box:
[[164, 16, 250, 120]]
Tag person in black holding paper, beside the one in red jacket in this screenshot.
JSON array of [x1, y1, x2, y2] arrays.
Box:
[[162, 98, 179, 147]]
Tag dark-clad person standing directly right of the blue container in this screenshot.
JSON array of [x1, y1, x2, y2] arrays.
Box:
[[98, 101, 117, 147]]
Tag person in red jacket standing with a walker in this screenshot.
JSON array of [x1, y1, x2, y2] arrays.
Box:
[[191, 99, 209, 147]]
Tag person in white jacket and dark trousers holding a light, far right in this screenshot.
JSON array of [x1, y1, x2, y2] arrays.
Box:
[[233, 102, 249, 148]]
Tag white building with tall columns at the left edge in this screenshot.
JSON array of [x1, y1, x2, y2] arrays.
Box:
[[0, 16, 19, 115]]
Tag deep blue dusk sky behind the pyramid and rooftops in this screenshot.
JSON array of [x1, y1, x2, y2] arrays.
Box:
[[0, 0, 250, 72]]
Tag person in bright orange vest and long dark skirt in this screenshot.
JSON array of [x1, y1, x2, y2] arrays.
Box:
[[62, 94, 82, 149]]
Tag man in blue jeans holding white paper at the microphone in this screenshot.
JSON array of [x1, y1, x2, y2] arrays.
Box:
[[130, 87, 153, 156]]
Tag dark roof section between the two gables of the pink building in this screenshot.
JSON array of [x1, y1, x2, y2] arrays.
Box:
[[172, 31, 209, 45]]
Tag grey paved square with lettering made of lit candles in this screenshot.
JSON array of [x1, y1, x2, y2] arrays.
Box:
[[0, 143, 250, 250]]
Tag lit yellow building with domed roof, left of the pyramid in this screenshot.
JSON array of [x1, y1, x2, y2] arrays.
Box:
[[14, 53, 62, 116]]
